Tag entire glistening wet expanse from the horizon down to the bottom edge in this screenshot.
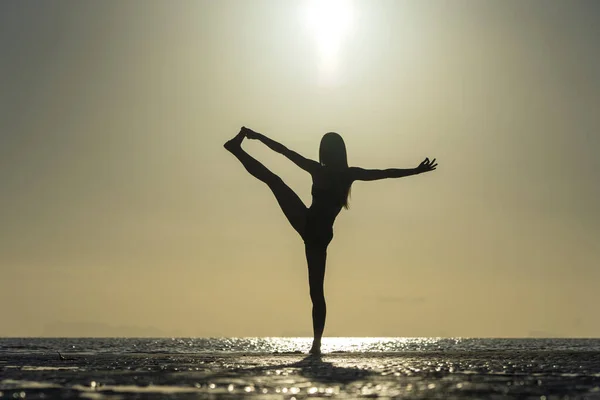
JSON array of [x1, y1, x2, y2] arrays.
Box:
[[0, 338, 600, 400]]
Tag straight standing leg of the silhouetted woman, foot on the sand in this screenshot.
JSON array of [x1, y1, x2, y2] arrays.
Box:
[[305, 245, 327, 354]]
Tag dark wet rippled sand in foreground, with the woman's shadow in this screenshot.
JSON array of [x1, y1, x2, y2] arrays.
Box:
[[0, 351, 600, 400]]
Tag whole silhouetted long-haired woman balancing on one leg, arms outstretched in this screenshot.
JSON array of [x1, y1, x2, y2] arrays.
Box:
[[224, 127, 437, 354]]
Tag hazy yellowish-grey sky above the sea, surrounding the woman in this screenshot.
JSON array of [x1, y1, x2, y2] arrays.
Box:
[[0, 0, 600, 337]]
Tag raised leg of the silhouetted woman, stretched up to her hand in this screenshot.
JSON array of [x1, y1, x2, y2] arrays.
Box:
[[224, 130, 307, 237]]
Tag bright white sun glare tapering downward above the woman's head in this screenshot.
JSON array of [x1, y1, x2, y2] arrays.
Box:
[[306, 0, 354, 82]]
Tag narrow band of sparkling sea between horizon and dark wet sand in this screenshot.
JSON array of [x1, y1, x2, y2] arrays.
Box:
[[0, 337, 600, 354]]
